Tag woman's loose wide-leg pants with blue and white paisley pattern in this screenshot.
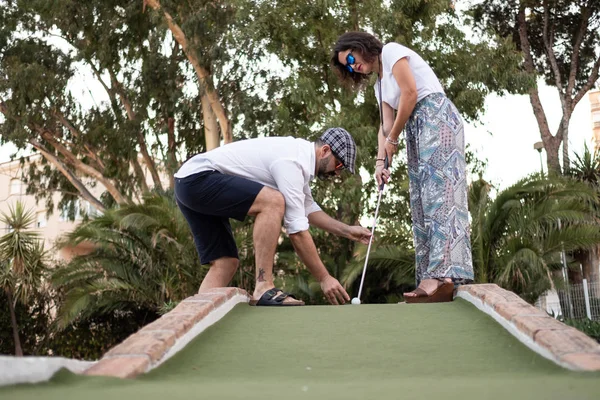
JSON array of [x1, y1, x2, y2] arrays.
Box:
[[406, 93, 473, 284]]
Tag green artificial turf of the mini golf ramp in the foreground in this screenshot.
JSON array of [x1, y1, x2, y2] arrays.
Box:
[[0, 300, 600, 400]]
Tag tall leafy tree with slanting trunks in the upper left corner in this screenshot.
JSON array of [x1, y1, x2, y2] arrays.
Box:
[[0, 0, 203, 210]]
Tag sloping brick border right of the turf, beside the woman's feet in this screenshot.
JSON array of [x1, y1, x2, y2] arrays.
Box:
[[456, 284, 600, 371]]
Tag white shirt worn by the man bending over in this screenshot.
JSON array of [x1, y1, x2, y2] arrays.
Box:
[[175, 137, 321, 234]]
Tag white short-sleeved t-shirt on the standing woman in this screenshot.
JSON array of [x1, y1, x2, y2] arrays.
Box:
[[374, 42, 444, 110]]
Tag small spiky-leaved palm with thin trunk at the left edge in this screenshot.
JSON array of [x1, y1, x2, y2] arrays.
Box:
[[0, 201, 46, 356]]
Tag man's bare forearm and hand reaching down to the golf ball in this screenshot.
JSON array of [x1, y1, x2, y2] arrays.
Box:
[[289, 231, 350, 304]]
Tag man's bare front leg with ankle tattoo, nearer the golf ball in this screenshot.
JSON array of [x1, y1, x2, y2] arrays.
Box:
[[248, 187, 297, 303]]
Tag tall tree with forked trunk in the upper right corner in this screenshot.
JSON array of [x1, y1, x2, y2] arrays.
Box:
[[472, 0, 600, 173]]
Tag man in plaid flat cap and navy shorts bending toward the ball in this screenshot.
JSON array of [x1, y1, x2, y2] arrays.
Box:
[[175, 128, 371, 306]]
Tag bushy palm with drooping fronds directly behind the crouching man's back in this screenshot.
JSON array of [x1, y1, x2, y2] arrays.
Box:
[[52, 193, 206, 327]]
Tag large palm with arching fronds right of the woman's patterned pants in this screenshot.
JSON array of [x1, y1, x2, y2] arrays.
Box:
[[469, 175, 600, 301]]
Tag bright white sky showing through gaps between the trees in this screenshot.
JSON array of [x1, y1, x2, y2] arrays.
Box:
[[0, 82, 592, 190]]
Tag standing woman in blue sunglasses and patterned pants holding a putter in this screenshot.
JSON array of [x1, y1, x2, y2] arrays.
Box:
[[331, 32, 473, 303]]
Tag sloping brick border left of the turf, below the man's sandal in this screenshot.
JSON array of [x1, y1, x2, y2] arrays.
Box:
[[83, 287, 250, 378]]
